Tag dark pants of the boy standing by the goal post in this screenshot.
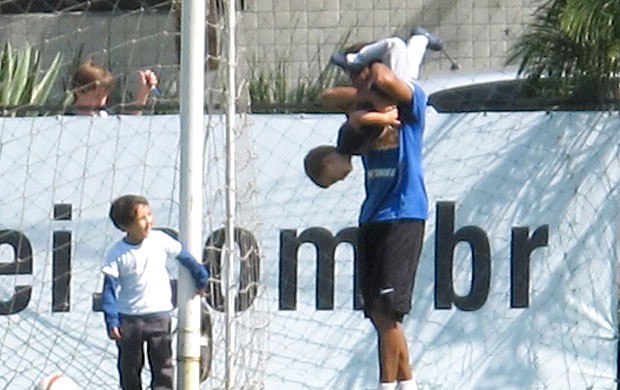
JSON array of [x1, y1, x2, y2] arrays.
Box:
[[116, 315, 174, 390]]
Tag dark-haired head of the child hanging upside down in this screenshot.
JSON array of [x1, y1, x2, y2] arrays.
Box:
[[304, 145, 353, 188]]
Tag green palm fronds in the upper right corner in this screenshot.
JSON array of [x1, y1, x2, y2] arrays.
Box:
[[507, 0, 620, 99]]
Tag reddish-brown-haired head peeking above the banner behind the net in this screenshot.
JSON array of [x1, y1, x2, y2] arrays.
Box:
[[71, 60, 114, 107]]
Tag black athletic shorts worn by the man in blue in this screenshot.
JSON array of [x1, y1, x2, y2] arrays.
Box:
[[358, 219, 424, 322]]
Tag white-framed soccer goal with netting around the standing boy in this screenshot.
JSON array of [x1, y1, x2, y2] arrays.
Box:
[[0, 0, 269, 389]]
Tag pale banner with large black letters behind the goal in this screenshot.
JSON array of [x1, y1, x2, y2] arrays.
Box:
[[0, 109, 620, 390]]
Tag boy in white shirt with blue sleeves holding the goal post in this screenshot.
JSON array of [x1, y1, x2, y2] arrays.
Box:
[[102, 195, 209, 390]]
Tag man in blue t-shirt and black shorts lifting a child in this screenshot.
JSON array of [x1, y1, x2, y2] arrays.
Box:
[[352, 63, 428, 390]]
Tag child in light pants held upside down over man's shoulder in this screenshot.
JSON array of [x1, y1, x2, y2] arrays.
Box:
[[304, 28, 443, 188]]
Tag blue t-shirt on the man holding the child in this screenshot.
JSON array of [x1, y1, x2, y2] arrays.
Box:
[[359, 84, 428, 224]]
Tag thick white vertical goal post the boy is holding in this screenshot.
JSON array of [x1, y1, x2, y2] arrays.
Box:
[[177, 0, 206, 390]]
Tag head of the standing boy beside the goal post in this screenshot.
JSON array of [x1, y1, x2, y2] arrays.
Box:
[[109, 195, 152, 234]]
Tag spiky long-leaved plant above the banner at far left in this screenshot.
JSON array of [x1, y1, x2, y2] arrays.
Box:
[[0, 43, 62, 112]]
